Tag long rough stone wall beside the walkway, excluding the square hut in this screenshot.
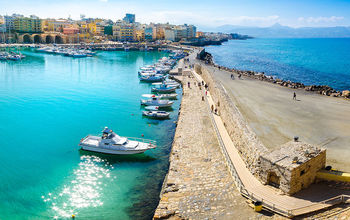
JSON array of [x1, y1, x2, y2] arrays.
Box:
[[195, 64, 268, 174]]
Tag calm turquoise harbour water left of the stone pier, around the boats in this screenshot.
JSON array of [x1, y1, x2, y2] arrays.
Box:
[[0, 49, 181, 219]]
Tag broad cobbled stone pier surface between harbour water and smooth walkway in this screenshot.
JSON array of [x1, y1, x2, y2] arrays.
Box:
[[154, 77, 254, 219]]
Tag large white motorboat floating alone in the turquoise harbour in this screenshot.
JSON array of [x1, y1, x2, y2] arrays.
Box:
[[79, 127, 156, 154]]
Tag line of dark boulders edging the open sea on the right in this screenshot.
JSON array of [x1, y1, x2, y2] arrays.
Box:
[[199, 50, 350, 99]]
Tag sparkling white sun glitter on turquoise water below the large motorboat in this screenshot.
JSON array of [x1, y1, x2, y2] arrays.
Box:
[[42, 155, 116, 218]]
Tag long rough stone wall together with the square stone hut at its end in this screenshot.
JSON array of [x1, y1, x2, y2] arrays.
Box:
[[195, 64, 326, 194]]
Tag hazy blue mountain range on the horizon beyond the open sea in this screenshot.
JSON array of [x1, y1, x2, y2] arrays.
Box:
[[211, 23, 350, 38]]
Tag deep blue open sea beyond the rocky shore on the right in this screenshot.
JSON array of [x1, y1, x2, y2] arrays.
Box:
[[206, 38, 350, 90]]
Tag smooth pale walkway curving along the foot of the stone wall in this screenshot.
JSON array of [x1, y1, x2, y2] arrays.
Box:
[[193, 67, 350, 216]]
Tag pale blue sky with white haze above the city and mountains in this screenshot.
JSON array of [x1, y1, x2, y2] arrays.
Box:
[[0, 0, 350, 27]]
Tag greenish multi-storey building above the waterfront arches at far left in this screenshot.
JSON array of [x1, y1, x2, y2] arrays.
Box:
[[13, 15, 43, 33]]
